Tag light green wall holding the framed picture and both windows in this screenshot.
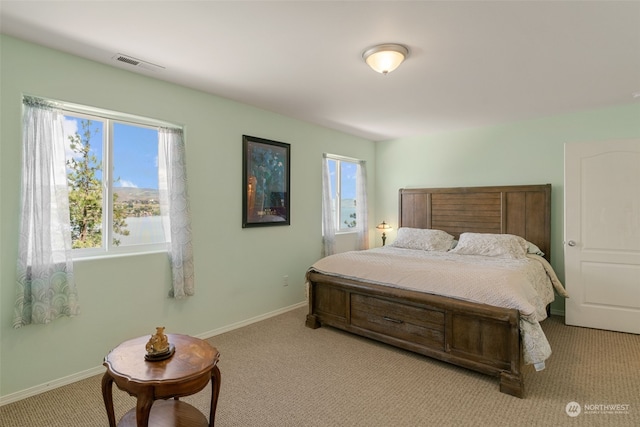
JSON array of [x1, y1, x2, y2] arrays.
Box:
[[0, 36, 375, 397]]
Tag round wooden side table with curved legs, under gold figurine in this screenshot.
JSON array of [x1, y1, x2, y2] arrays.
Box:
[[102, 334, 220, 427]]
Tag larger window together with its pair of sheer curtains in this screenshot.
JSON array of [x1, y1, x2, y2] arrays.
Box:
[[13, 95, 195, 320]]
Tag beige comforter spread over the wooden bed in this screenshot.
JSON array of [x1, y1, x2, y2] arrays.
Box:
[[310, 246, 568, 370]]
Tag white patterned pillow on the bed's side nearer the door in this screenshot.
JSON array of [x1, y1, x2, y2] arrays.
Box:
[[449, 233, 528, 259]]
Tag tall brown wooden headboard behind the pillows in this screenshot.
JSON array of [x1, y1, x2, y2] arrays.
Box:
[[398, 184, 551, 260]]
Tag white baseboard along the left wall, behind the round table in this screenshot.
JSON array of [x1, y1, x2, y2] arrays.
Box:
[[0, 301, 307, 406]]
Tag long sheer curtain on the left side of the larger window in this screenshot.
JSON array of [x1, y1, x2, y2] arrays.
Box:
[[13, 97, 79, 328]]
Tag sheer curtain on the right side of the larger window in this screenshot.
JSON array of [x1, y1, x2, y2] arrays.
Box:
[[158, 128, 195, 298]]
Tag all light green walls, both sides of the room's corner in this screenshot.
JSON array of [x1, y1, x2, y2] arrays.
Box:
[[0, 36, 640, 398]]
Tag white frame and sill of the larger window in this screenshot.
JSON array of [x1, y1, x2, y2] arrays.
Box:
[[58, 101, 182, 259]]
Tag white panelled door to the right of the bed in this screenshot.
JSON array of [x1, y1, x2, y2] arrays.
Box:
[[564, 140, 640, 334]]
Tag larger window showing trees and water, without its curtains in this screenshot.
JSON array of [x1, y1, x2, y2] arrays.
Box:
[[63, 108, 172, 256]]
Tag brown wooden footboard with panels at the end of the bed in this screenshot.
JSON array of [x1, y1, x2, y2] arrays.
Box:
[[306, 273, 524, 398]]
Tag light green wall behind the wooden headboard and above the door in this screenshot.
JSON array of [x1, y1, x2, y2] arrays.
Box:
[[376, 103, 640, 312]]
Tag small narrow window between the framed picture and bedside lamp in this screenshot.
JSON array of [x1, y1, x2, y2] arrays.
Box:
[[327, 156, 358, 232]]
